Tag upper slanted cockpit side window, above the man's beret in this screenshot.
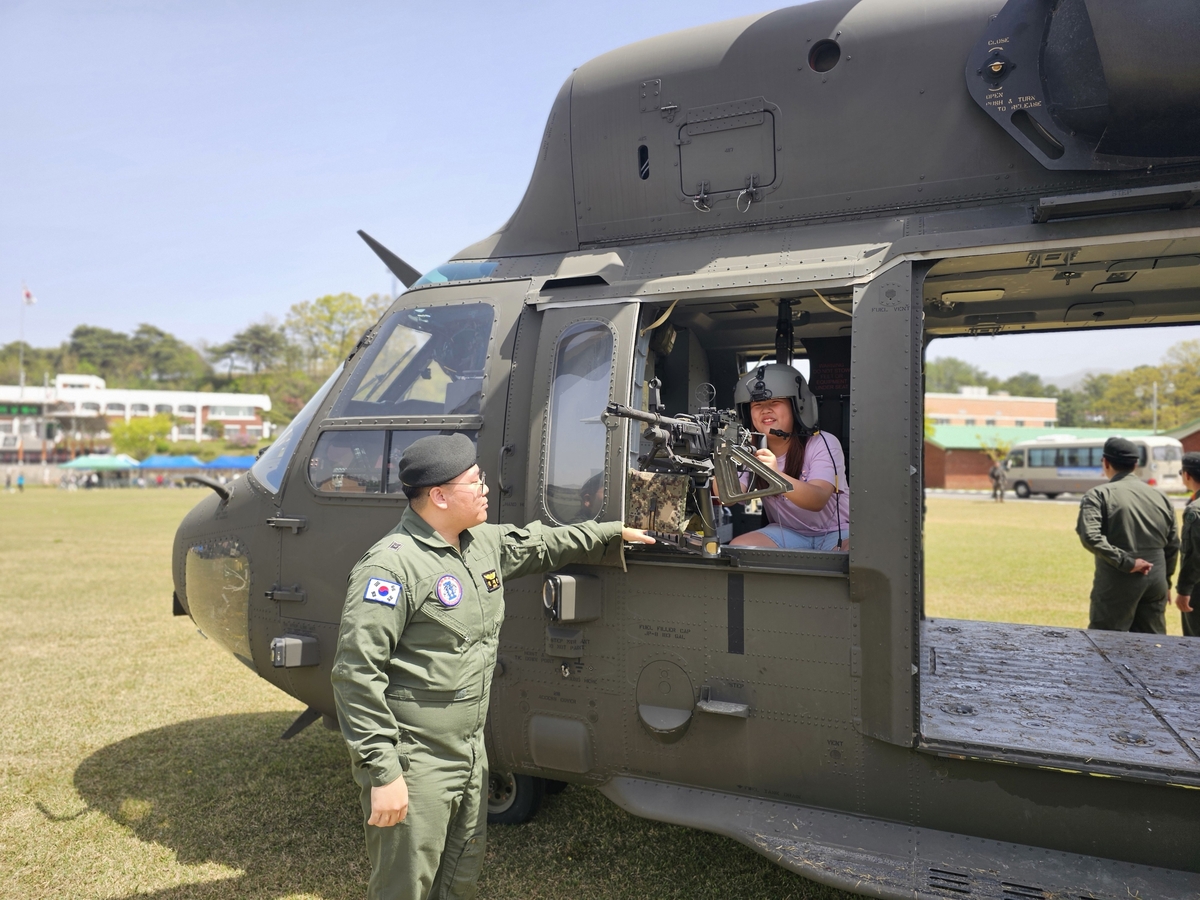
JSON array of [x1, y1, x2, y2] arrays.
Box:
[[331, 304, 494, 418]]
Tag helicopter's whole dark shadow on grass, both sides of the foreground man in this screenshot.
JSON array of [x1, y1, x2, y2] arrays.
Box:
[[74, 712, 848, 900]]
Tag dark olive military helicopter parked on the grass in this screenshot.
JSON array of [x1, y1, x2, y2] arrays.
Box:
[[173, 0, 1200, 900]]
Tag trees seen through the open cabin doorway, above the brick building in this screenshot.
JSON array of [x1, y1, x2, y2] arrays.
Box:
[[925, 341, 1200, 431]]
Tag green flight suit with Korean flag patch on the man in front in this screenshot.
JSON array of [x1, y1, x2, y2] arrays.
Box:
[[332, 509, 622, 900]]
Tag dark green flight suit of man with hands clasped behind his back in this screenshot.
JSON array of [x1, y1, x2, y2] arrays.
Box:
[[1075, 473, 1180, 635]]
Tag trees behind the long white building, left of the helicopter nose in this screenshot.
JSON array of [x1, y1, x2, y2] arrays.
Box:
[[0, 293, 391, 424]]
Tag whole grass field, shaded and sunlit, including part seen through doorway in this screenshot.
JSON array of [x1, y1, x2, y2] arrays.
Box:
[[0, 490, 1177, 900]]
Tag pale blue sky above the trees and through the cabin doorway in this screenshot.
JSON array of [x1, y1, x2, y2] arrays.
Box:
[[0, 0, 1200, 376]]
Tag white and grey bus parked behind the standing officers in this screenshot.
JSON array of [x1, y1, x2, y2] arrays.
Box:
[[1004, 434, 1187, 498]]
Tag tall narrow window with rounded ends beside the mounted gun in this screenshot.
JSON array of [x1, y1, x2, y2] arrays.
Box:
[[546, 322, 613, 524]]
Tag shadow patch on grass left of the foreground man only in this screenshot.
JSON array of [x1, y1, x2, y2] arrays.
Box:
[[74, 713, 370, 900]]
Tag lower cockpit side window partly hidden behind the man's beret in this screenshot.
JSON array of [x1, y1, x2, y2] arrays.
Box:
[[308, 430, 476, 496]]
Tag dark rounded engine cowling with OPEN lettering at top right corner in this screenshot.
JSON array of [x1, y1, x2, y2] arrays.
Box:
[[966, 0, 1200, 169]]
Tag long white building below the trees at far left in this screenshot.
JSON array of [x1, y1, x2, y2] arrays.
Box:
[[0, 374, 271, 456]]
